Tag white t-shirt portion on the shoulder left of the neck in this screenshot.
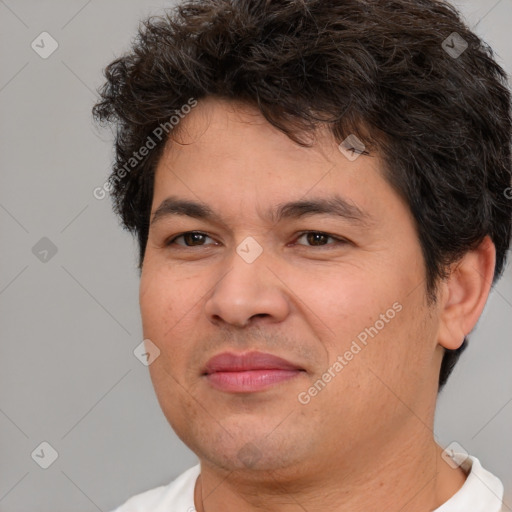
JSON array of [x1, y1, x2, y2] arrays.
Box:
[[112, 464, 201, 512]]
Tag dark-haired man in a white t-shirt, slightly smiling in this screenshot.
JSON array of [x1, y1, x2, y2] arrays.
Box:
[[94, 0, 512, 512]]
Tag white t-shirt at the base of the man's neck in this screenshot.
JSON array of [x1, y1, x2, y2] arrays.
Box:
[[113, 454, 503, 512]]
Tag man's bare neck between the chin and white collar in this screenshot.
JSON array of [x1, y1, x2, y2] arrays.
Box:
[[195, 429, 466, 512]]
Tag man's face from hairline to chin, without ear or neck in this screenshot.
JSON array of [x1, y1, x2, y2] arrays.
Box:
[[140, 99, 441, 472]]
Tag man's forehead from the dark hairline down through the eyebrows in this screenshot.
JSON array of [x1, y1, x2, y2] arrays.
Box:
[[152, 98, 408, 225]]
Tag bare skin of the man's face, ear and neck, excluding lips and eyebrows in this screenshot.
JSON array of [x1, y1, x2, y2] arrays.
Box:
[[140, 97, 495, 512]]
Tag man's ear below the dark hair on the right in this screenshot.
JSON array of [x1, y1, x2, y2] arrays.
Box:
[[438, 236, 496, 350]]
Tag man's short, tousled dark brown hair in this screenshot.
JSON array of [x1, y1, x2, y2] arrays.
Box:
[[93, 0, 512, 389]]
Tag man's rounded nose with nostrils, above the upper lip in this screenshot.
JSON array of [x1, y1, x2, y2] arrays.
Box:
[[205, 247, 290, 327]]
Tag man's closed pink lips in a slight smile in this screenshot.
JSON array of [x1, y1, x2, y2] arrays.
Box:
[[202, 352, 306, 393]]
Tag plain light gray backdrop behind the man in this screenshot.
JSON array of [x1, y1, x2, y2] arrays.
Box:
[[0, 0, 512, 512]]
